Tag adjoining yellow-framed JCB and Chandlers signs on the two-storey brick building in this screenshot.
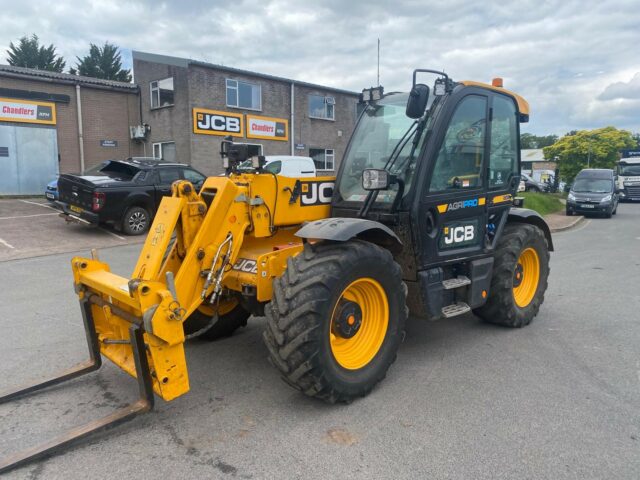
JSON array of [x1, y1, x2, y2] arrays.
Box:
[[193, 108, 289, 142]]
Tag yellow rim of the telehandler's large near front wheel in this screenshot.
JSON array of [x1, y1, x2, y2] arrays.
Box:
[[329, 278, 389, 370]]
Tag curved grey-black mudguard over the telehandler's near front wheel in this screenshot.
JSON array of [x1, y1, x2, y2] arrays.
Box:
[[296, 217, 402, 253]]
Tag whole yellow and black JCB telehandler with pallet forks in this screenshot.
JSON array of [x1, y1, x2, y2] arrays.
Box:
[[0, 70, 553, 472]]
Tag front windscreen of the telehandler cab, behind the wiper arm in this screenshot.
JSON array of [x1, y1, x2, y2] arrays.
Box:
[[338, 93, 425, 203]]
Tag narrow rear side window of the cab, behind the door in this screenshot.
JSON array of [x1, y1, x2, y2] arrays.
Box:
[[489, 96, 519, 188]]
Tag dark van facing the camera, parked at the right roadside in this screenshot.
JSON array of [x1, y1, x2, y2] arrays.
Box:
[[566, 168, 619, 218]]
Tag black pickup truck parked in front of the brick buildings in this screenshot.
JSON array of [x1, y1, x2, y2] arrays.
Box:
[[56, 157, 206, 235]]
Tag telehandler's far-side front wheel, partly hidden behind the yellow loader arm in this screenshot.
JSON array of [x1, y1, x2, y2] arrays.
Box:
[[183, 299, 251, 341]]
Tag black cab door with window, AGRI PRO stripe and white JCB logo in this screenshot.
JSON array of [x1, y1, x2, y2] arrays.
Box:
[[416, 89, 490, 269]]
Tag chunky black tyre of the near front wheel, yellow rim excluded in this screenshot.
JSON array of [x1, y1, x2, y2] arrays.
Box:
[[264, 240, 408, 403]]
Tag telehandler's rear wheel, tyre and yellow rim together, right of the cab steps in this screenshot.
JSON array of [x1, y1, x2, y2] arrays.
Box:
[[475, 223, 549, 327]]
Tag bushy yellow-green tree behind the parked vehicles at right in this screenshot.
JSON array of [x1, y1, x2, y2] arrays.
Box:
[[544, 127, 636, 182]]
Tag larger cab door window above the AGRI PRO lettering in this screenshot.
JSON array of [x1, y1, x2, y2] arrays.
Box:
[[429, 95, 487, 192]]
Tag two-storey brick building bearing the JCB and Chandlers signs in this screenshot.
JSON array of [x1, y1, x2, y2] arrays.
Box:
[[133, 51, 358, 174]]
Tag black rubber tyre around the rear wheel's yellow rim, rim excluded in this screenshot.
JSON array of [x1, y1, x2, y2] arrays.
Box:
[[475, 223, 549, 328]]
